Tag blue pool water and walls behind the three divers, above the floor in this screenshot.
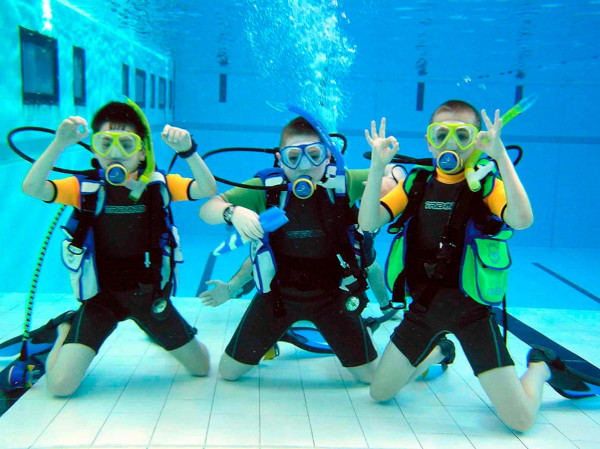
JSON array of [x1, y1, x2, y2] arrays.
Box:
[[0, 0, 600, 302]]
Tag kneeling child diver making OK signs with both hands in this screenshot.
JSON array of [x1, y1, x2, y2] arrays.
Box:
[[359, 100, 579, 431]]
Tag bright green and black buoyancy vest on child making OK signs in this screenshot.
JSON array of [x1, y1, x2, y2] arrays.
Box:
[[386, 161, 513, 304]]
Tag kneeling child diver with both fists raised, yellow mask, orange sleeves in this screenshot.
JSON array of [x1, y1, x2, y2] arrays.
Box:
[[23, 101, 216, 396]]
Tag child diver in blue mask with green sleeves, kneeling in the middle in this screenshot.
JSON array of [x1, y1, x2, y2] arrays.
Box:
[[200, 113, 398, 383]]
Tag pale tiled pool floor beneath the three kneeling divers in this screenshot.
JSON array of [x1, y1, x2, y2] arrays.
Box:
[[0, 249, 600, 449]]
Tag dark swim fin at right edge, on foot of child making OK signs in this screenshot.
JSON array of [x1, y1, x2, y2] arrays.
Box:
[[527, 345, 595, 399]]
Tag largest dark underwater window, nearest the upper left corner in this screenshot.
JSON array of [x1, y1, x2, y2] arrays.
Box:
[[19, 27, 58, 104]]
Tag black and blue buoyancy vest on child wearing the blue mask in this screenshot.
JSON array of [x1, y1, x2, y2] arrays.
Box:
[[250, 165, 367, 300]]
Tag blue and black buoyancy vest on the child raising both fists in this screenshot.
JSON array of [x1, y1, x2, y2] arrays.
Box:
[[62, 170, 183, 301]]
